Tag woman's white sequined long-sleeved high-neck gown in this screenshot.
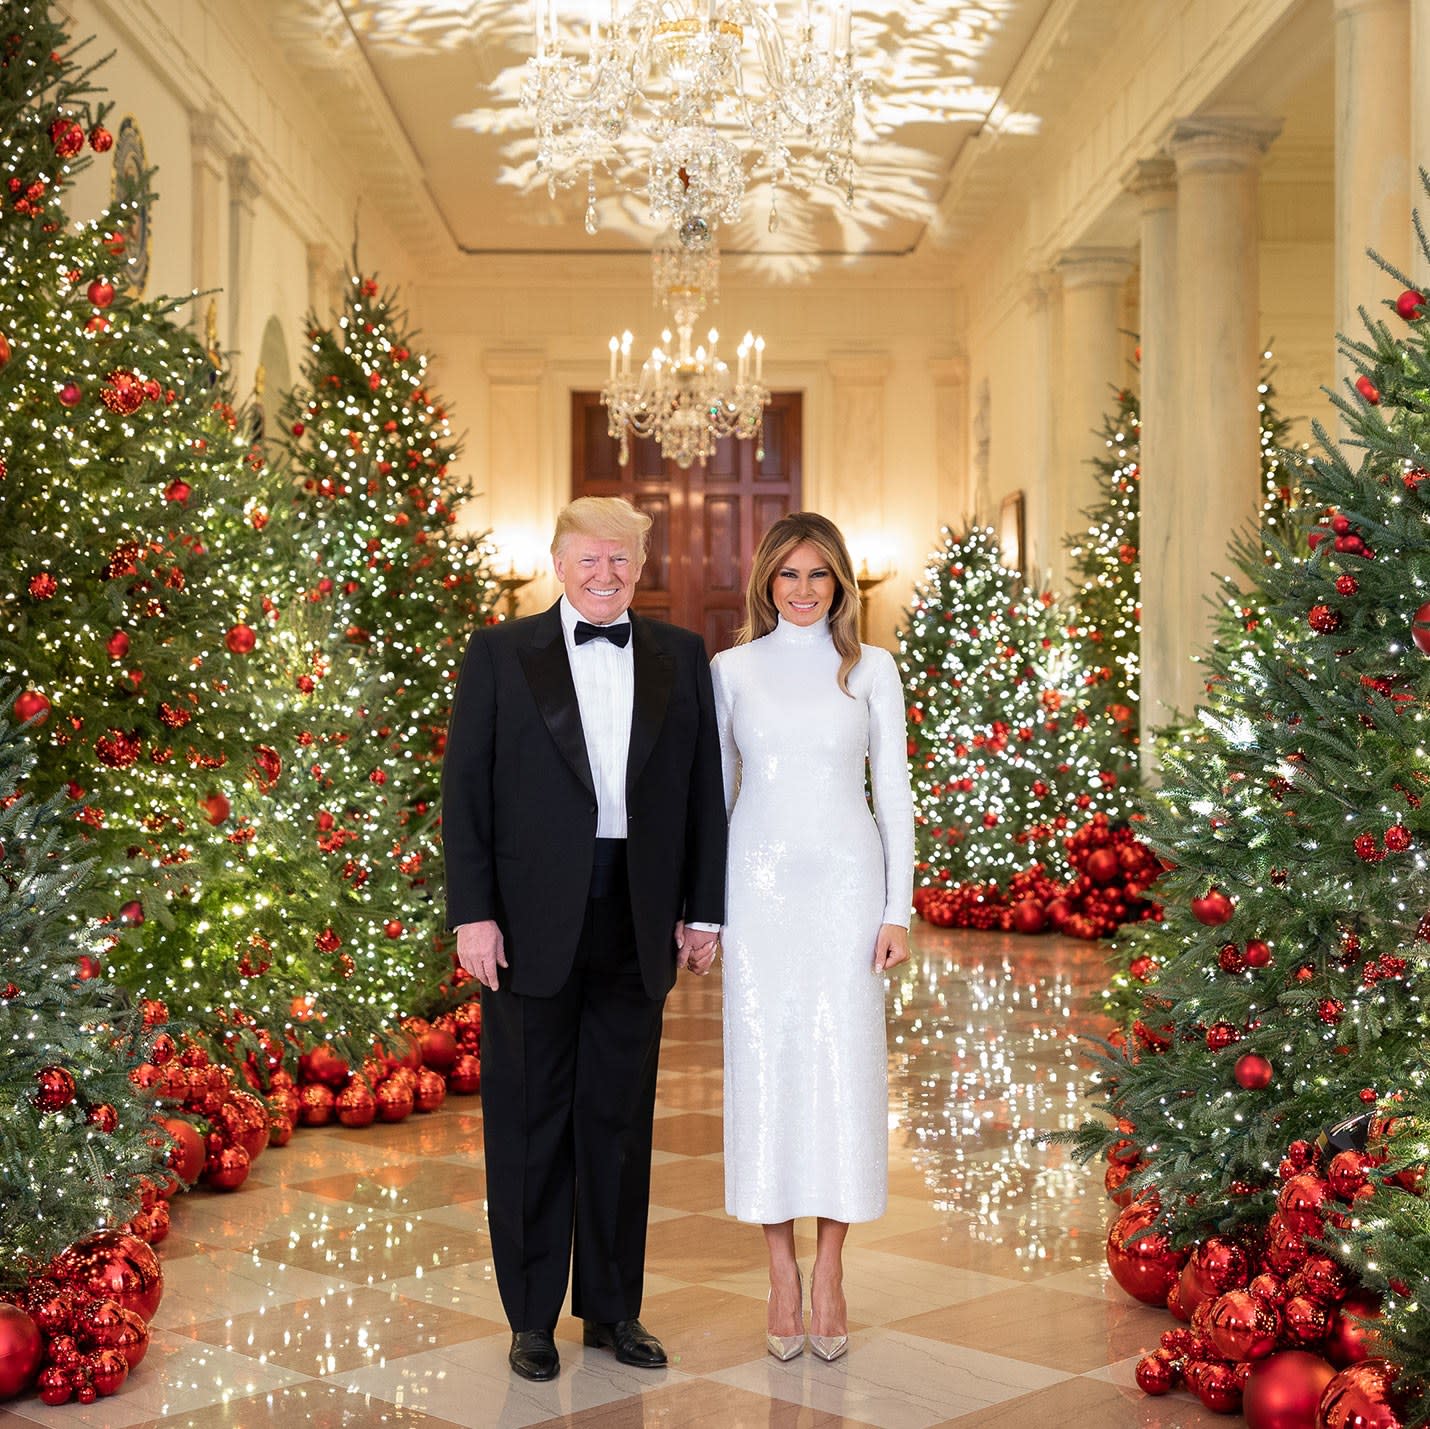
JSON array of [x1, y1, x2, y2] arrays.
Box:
[[714, 621, 914, 1223]]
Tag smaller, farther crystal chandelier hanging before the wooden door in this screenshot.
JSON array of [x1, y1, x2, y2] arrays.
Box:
[[601, 233, 769, 468]]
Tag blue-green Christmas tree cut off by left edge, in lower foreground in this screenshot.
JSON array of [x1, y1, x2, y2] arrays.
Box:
[[0, 706, 164, 1292]]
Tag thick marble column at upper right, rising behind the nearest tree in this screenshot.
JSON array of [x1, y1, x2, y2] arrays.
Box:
[[1336, 0, 1412, 378]]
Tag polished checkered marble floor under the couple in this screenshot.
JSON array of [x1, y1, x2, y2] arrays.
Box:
[[0, 927, 1226, 1429]]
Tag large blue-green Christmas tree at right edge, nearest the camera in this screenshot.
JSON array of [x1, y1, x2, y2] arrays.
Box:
[[1080, 208, 1430, 1316]]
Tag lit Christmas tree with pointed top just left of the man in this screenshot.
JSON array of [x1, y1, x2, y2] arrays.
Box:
[[273, 262, 495, 1013]]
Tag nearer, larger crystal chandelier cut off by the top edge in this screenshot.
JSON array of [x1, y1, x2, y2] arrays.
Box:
[[522, 0, 867, 240]]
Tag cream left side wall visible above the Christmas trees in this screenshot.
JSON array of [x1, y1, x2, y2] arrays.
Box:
[[63, 0, 413, 392]]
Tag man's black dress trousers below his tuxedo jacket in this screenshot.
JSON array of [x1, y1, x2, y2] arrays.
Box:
[[482, 867, 665, 1330]]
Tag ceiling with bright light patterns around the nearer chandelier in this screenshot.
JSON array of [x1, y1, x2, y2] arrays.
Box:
[[259, 0, 1052, 263]]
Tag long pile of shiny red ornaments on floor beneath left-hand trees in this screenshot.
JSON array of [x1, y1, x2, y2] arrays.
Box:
[[0, 974, 482, 1405]]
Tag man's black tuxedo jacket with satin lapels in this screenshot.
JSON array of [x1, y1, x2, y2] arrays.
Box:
[[442, 601, 725, 997]]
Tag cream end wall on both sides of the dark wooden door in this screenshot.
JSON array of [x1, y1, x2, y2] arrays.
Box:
[[413, 268, 967, 641]]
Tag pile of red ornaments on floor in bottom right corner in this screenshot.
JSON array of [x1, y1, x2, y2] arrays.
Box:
[[1107, 1130, 1423, 1429]]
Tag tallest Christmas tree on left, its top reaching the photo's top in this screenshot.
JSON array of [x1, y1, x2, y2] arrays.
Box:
[[0, 4, 398, 1056]]
